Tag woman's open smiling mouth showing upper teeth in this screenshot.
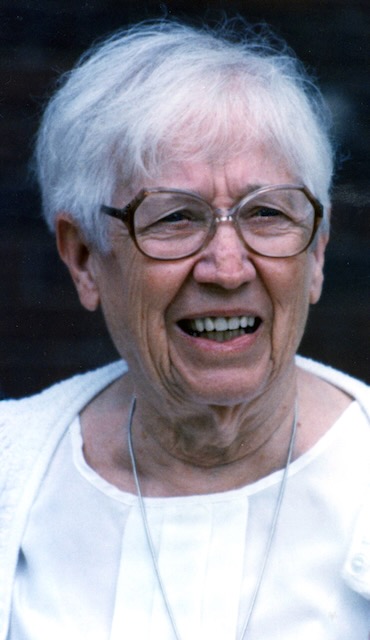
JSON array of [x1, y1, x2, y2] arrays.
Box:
[[178, 316, 262, 342]]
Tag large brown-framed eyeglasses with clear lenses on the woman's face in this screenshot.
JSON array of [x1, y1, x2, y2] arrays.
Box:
[[101, 184, 323, 260]]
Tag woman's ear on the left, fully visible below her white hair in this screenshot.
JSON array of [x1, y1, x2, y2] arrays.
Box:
[[56, 212, 100, 311]]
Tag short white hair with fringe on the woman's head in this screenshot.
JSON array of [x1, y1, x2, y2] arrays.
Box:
[[36, 20, 333, 250]]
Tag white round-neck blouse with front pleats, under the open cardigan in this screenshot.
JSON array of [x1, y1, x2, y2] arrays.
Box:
[[8, 402, 370, 640]]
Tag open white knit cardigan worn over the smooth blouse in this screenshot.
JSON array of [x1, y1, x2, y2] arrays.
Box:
[[0, 357, 370, 640]]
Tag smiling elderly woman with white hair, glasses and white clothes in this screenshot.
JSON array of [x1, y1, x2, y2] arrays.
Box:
[[0, 17, 370, 640]]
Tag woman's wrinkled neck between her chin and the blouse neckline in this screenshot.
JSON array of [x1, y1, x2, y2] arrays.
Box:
[[127, 362, 297, 493]]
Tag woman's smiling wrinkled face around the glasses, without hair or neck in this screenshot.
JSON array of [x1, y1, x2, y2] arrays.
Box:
[[76, 150, 325, 405]]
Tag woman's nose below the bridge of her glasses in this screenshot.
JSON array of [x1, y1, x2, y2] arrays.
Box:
[[193, 218, 256, 289]]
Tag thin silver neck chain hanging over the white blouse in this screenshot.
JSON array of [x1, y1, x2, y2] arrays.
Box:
[[127, 396, 298, 640]]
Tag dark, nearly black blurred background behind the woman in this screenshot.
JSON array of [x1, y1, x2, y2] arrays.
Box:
[[0, 0, 370, 397]]
